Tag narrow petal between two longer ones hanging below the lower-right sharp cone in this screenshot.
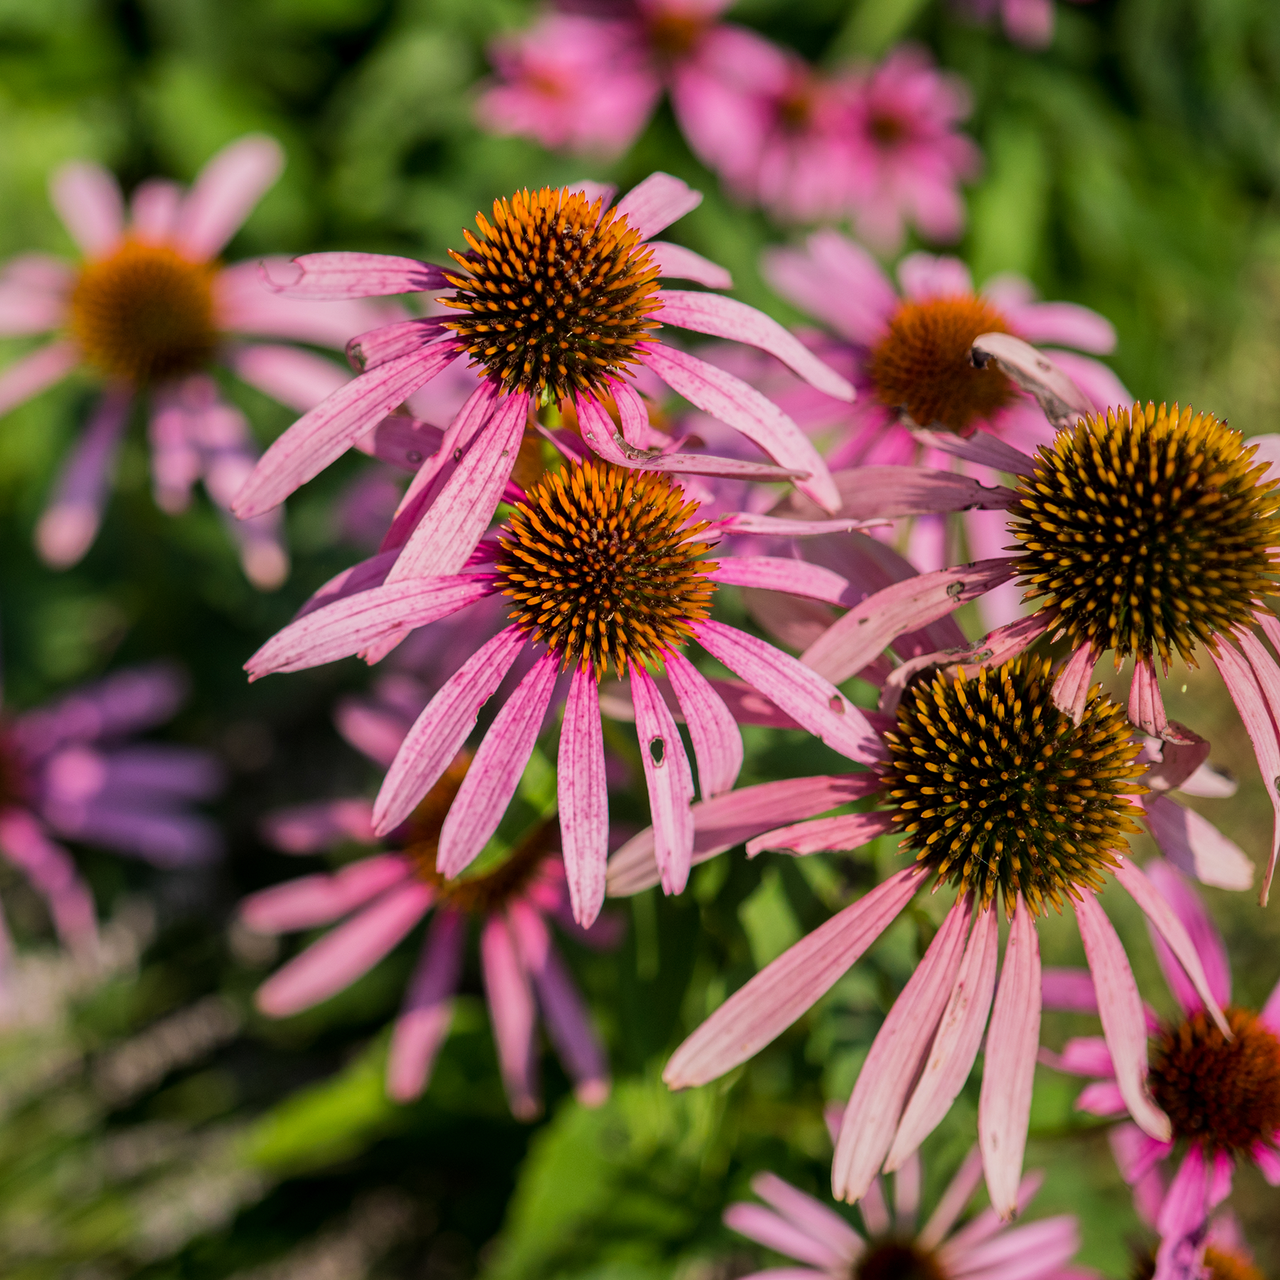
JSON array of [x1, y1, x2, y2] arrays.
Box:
[[884, 908, 1009, 1171]]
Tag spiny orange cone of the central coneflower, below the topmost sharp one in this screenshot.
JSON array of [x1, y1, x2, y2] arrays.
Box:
[[498, 462, 716, 678]]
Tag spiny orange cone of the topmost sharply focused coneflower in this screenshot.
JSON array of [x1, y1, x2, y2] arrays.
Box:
[[440, 187, 658, 403]]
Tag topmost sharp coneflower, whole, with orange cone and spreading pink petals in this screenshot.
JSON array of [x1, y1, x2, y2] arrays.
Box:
[[236, 173, 854, 581]]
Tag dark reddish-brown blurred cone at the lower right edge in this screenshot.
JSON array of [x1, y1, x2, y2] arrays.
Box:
[[1149, 1009, 1280, 1156]]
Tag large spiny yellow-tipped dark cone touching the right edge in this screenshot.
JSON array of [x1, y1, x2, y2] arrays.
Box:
[[1010, 403, 1280, 667]]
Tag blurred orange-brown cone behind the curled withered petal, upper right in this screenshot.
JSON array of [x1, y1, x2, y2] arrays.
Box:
[[868, 294, 1016, 435]]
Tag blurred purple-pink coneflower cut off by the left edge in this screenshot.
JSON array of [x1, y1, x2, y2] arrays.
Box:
[[0, 663, 221, 965]]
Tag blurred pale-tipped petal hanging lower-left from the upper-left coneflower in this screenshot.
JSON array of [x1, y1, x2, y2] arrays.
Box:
[[36, 387, 133, 568]]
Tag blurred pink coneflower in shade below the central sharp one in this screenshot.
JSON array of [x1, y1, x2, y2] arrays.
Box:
[[241, 751, 611, 1120]]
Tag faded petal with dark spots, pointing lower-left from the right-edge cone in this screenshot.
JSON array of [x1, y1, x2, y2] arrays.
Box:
[[801, 559, 1014, 681]]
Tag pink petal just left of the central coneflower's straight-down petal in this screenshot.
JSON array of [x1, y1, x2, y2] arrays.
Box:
[[435, 653, 558, 879]]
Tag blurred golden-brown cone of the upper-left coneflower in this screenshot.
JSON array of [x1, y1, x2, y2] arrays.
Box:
[[69, 239, 218, 387]]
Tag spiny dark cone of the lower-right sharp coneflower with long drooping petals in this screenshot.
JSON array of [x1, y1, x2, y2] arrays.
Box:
[[882, 657, 1146, 914]]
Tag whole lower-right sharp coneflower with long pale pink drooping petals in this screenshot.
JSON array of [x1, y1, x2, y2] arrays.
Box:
[[655, 657, 1225, 1217]]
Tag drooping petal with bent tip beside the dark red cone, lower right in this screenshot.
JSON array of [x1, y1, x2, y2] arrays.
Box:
[[1071, 891, 1170, 1142]]
